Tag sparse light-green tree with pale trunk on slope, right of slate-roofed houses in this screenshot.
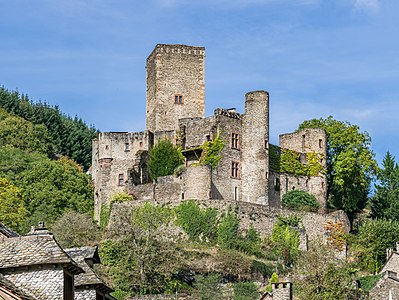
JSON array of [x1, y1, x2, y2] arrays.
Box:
[[106, 203, 180, 294]]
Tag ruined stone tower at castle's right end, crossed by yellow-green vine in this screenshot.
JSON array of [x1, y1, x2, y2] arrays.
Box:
[[280, 128, 327, 208]]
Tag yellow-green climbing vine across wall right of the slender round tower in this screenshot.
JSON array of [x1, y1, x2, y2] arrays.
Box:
[[269, 145, 325, 176]]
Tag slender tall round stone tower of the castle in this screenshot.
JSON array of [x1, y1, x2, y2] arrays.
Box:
[[241, 91, 269, 205]]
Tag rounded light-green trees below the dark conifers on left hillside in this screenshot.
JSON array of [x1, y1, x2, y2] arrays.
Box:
[[0, 146, 93, 230]]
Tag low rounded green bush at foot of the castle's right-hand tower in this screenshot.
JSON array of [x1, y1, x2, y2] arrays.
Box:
[[282, 190, 320, 211]]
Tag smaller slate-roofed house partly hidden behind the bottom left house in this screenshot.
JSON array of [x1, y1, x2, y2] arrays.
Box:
[[65, 247, 115, 300]]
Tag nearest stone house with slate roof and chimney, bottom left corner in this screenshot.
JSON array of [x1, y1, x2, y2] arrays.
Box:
[[0, 227, 83, 300]]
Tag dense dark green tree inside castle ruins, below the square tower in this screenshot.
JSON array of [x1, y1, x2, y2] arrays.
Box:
[[148, 139, 184, 181]]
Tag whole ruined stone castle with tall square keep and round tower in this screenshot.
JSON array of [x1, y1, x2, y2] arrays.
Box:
[[92, 45, 326, 219]]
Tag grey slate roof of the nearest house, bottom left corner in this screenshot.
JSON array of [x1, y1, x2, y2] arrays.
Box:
[[0, 234, 83, 274]]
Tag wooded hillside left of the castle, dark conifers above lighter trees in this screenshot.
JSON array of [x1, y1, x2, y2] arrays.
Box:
[[0, 88, 95, 232]]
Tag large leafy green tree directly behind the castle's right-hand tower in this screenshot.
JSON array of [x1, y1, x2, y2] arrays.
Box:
[[298, 116, 378, 214]]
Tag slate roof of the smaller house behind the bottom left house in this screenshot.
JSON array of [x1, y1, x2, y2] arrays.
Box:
[[65, 247, 113, 294]]
